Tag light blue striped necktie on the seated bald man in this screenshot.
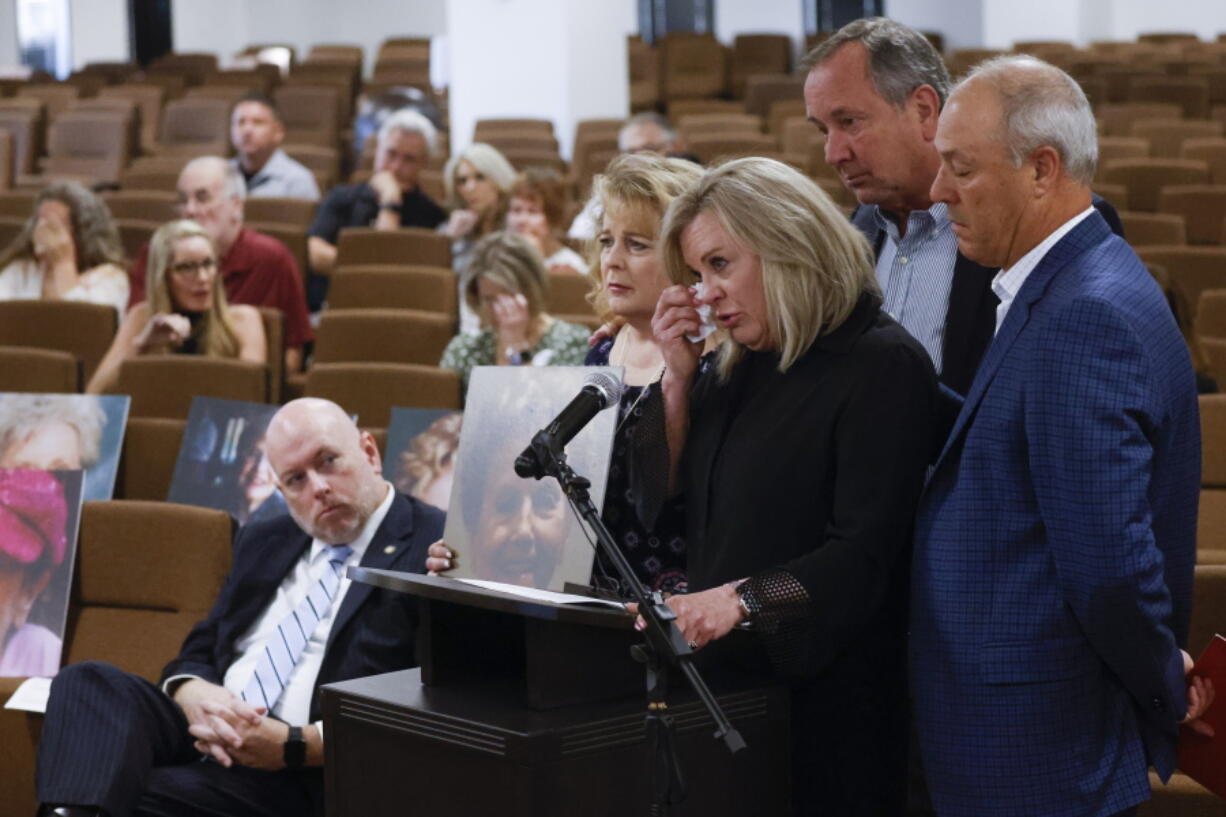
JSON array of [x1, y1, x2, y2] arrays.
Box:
[[243, 545, 353, 713]]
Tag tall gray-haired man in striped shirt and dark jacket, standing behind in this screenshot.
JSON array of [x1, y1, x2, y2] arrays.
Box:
[[804, 17, 1123, 394]]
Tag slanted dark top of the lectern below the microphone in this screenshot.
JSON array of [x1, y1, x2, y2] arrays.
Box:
[[348, 567, 634, 629]]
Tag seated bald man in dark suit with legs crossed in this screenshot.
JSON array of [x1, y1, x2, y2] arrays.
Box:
[[38, 399, 443, 817]]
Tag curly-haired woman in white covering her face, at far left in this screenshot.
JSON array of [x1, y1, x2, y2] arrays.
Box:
[[0, 182, 128, 316]]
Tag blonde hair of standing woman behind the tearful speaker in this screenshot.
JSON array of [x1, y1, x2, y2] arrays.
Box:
[[587, 153, 702, 323]]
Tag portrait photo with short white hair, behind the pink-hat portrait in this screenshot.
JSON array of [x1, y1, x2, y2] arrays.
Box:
[[0, 393, 130, 499]]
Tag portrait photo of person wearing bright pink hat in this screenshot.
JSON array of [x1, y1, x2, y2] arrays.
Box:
[[0, 469, 81, 677]]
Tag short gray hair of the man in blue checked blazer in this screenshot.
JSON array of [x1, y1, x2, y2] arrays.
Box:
[[954, 55, 1098, 186]]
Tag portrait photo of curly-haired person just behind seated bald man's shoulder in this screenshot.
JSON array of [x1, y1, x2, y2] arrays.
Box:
[[384, 407, 463, 510]]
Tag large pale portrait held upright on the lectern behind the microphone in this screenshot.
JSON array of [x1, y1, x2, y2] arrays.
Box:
[[444, 367, 617, 590]]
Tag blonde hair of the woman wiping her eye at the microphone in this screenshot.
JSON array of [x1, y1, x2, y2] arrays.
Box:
[[661, 157, 879, 380]]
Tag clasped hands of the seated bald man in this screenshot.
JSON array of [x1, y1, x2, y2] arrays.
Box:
[[174, 678, 289, 770]]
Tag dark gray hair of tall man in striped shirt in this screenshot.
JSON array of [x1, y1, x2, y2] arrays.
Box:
[[801, 17, 950, 108]]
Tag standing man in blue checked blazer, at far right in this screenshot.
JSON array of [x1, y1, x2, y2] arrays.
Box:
[[911, 58, 1211, 817]]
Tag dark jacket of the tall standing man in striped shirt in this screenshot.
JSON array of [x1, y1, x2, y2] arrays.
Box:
[[851, 195, 1124, 395]]
